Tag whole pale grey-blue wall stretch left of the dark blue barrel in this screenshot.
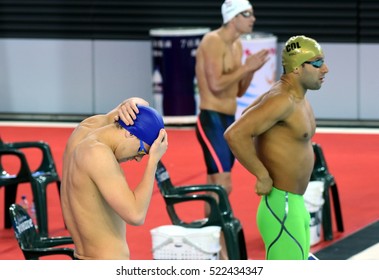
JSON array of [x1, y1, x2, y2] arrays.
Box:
[[0, 39, 152, 114]]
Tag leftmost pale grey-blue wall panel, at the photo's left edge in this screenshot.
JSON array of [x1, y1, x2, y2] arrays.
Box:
[[0, 39, 93, 114]]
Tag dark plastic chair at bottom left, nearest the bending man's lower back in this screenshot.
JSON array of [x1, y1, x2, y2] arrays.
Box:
[[9, 203, 74, 260]]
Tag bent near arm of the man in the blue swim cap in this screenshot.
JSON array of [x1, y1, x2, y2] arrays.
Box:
[[90, 129, 168, 226]]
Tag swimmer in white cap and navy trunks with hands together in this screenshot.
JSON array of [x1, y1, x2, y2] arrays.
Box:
[[195, 0, 268, 259]]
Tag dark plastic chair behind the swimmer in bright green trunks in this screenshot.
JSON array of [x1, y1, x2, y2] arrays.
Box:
[[311, 143, 344, 240]]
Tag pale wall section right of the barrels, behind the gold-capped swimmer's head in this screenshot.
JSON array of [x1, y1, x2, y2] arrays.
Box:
[[278, 43, 379, 120]]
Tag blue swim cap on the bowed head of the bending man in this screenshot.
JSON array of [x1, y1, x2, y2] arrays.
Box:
[[118, 105, 164, 146]]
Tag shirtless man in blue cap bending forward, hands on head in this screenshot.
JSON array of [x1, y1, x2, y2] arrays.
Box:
[[60, 98, 168, 260]]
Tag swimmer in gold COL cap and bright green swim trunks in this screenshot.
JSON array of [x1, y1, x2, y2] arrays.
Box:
[[224, 36, 328, 260]]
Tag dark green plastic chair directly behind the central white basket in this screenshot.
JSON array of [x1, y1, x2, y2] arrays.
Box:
[[155, 161, 247, 260]]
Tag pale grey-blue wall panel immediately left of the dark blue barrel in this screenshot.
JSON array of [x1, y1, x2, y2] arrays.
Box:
[[94, 41, 153, 113]]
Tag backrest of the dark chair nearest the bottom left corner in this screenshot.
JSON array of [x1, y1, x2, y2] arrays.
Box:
[[9, 203, 40, 250]]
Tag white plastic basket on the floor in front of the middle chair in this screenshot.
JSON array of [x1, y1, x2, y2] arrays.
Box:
[[150, 225, 221, 260]]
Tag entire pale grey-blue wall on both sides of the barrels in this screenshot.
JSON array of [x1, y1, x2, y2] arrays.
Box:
[[0, 39, 379, 120]]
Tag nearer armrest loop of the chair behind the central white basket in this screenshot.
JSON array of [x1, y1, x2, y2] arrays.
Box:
[[164, 194, 222, 228]]
